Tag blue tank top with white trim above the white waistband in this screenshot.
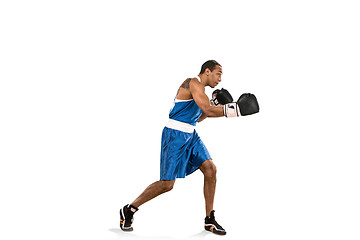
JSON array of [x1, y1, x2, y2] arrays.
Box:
[[169, 77, 202, 126]]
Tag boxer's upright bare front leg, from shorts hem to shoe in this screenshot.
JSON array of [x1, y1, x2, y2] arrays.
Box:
[[199, 159, 216, 217]]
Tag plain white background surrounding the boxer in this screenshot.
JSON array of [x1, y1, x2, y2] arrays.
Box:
[[0, 0, 360, 240]]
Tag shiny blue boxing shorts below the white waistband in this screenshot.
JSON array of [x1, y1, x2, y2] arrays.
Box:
[[160, 127, 211, 180]]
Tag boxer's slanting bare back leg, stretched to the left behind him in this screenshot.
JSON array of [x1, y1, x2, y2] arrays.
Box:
[[131, 180, 175, 208]]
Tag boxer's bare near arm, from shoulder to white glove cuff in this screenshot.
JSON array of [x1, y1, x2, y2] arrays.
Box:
[[190, 79, 224, 117]]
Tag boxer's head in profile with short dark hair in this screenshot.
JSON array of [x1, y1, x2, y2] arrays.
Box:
[[199, 60, 222, 88]]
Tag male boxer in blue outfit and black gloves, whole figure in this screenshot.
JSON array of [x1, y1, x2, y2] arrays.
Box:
[[120, 60, 259, 235]]
